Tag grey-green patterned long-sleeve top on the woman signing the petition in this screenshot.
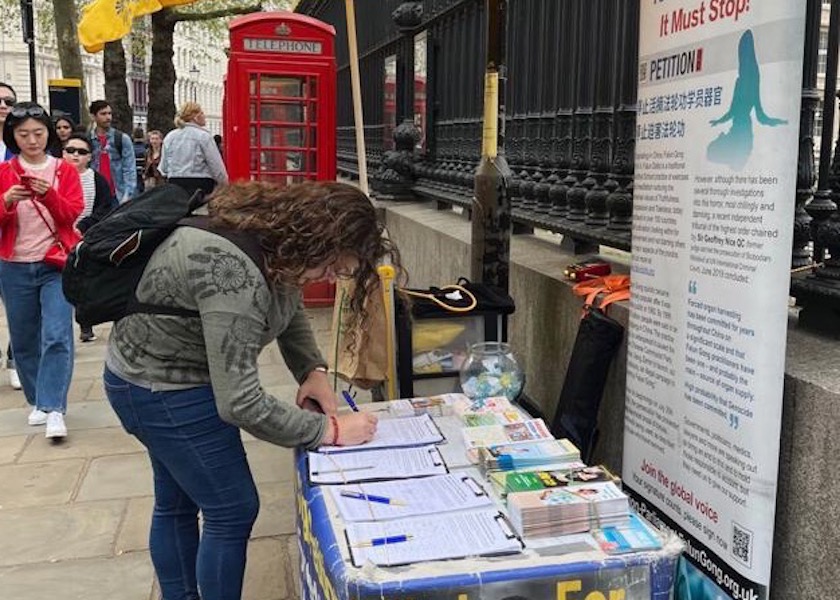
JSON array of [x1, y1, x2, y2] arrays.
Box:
[[106, 227, 327, 448]]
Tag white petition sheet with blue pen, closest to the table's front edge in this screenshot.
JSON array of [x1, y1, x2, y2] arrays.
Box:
[[345, 509, 523, 567]]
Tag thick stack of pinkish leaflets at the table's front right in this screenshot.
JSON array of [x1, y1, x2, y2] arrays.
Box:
[[507, 482, 630, 538]]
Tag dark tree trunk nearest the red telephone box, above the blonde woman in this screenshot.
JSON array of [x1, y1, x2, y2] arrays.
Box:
[[148, 8, 175, 135]]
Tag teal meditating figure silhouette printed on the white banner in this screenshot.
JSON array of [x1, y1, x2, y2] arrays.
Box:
[[706, 30, 787, 171]]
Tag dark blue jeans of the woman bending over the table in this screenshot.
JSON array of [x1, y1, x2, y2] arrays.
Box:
[[104, 368, 259, 600]]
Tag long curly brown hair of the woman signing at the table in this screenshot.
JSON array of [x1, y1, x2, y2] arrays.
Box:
[[208, 181, 404, 323]]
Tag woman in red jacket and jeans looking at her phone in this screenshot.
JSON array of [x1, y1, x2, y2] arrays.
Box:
[[0, 102, 84, 438]]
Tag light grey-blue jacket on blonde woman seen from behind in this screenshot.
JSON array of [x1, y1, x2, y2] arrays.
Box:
[[158, 123, 228, 185]]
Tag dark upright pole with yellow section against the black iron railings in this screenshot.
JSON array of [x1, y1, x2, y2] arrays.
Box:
[[471, 0, 511, 290]]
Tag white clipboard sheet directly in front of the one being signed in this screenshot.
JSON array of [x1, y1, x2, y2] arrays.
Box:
[[308, 446, 448, 483]]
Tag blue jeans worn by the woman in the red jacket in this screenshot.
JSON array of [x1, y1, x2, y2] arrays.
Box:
[[0, 261, 73, 413]]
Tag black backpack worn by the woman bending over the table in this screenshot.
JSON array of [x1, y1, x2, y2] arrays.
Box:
[[62, 184, 265, 326]]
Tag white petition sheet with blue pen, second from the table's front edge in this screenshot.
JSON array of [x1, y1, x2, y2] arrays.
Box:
[[332, 474, 493, 521]]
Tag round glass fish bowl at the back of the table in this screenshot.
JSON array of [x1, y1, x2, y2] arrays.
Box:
[[459, 342, 525, 402]]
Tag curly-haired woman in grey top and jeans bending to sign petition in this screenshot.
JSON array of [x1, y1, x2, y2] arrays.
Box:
[[104, 182, 399, 600]]
